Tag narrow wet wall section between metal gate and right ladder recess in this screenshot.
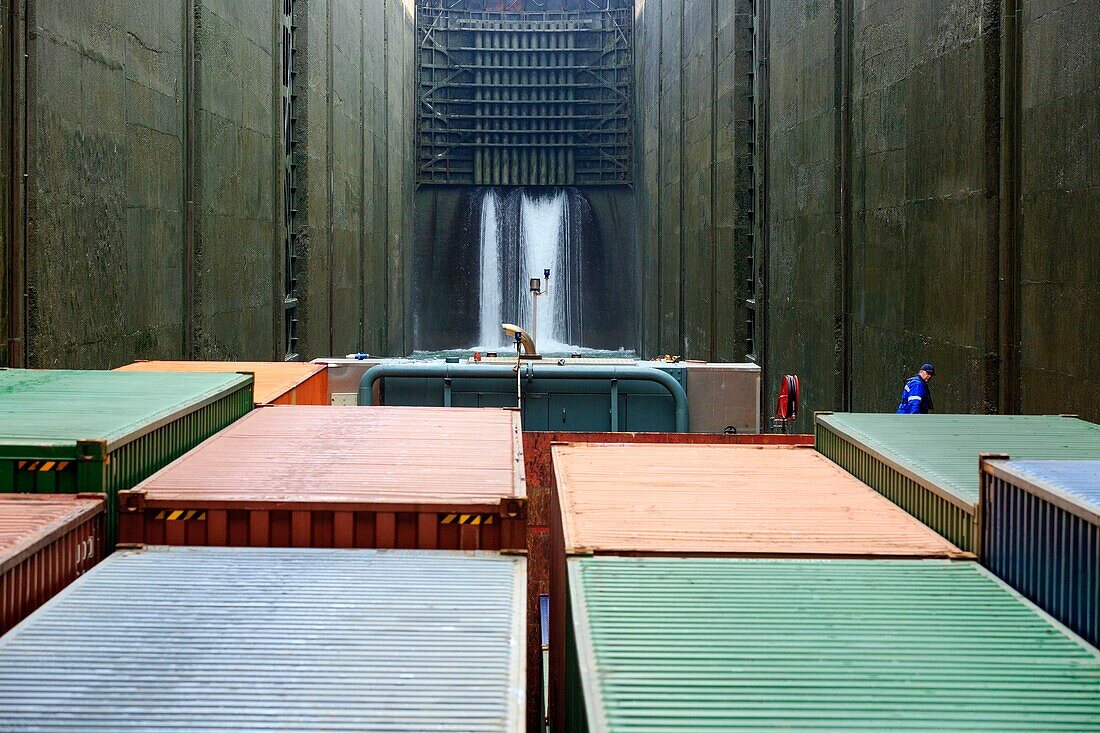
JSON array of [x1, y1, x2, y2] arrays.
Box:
[[635, 0, 752, 360]]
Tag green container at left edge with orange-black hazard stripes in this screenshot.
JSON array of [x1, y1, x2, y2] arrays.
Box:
[[0, 369, 252, 541]]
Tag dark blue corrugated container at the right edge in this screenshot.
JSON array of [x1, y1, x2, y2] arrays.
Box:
[[980, 457, 1100, 646]]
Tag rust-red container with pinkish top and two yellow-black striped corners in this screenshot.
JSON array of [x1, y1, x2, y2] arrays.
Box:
[[121, 406, 526, 550]]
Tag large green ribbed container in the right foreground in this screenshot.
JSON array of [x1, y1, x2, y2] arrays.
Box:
[[567, 557, 1100, 733]]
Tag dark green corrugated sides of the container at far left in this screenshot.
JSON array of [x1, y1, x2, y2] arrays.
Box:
[[0, 378, 253, 548]]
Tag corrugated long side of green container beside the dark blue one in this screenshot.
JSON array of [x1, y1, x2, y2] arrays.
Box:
[[814, 419, 980, 553]]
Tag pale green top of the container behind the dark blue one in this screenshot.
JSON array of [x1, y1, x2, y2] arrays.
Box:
[[817, 413, 1100, 504]]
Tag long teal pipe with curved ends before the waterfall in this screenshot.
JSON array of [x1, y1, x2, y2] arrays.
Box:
[[359, 362, 688, 433]]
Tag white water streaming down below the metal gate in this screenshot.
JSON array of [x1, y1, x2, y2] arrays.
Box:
[[475, 188, 580, 352]]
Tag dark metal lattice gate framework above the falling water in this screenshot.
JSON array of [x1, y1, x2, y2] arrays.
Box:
[[417, 0, 634, 186]]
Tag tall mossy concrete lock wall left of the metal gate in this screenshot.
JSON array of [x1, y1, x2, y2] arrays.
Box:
[[0, 0, 414, 367]]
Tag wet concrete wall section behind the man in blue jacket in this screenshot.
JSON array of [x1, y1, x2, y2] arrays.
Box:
[[763, 0, 1100, 429]]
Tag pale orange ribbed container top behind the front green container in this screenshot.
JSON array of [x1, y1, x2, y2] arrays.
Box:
[[552, 444, 965, 557]]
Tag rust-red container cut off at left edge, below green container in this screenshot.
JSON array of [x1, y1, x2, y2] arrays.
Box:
[[0, 494, 105, 634]]
